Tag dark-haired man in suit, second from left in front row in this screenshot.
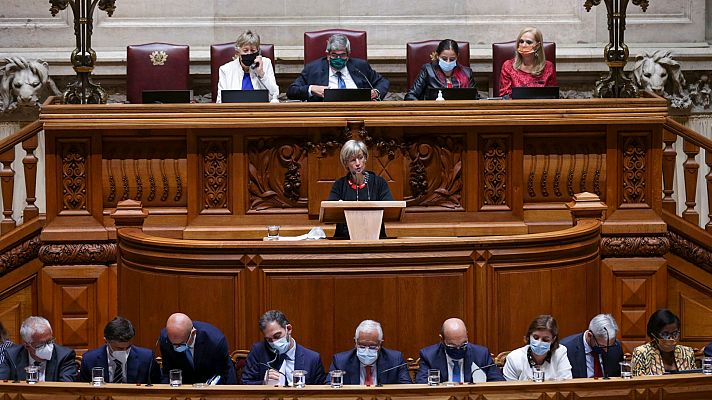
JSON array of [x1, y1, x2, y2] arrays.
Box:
[[79, 317, 161, 383]]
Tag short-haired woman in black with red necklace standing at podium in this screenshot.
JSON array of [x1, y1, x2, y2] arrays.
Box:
[[328, 140, 393, 239]]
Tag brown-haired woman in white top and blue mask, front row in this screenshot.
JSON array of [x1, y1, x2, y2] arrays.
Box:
[[504, 315, 572, 381]]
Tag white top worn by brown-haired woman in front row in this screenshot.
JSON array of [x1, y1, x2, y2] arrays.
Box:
[[504, 344, 572, 381]]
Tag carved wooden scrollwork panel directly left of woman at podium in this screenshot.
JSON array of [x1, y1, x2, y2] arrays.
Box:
[[247, 137, 306, 213]]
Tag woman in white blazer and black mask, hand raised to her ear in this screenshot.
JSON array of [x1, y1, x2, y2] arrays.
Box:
[[216, 31, 279, 103]]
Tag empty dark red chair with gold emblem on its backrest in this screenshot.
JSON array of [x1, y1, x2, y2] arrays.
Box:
[[126, 43, 190, 104]]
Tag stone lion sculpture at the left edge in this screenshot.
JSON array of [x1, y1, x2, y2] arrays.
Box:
[[0, 57, 62, 112]]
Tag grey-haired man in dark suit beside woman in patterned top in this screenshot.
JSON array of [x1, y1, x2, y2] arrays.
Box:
[[561, 314, 623, 378]]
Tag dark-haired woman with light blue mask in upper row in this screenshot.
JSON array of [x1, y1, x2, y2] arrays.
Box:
[[405, 39, 476, 100]]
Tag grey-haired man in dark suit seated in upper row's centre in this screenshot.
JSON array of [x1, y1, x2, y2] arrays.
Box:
[[287, 34, 390, 101]]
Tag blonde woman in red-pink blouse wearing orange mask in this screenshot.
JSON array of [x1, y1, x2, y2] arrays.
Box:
[[499, 28, 558, 96]]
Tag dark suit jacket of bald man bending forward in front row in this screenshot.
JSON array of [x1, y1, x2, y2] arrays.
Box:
[[159, 321, 237, 385]]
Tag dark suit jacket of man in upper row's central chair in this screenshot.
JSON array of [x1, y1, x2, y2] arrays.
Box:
[[287, 57, 391, 101]]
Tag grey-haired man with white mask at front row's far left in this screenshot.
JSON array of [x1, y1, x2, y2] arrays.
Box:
[[0, 317, 77, 382]]
